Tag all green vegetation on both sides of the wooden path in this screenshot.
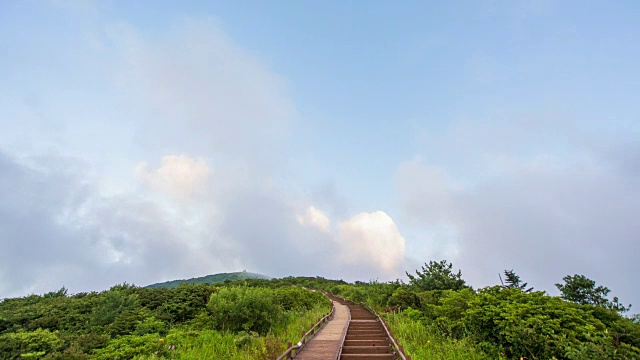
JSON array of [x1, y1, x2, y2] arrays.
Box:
[[0, 268, 640, 360]]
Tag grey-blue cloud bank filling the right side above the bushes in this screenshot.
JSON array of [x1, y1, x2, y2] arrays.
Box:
[[396, 121, 640, 301]]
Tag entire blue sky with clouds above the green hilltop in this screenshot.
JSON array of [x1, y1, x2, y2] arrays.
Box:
[[0, 0, 640, 311]]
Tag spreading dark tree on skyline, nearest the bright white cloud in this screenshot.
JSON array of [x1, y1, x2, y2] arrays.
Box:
[[406, 260, 468, 290]]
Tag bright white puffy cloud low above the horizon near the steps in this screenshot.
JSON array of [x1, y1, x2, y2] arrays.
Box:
[[340, 211, 405, 273]]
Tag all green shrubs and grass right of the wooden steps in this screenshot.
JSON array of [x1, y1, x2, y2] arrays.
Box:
[[337, 268, 640, 359]]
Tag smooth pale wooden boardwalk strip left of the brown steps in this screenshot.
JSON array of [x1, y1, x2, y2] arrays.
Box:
[[295, 301, 350, 360]]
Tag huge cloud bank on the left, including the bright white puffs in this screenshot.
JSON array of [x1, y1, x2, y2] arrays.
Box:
[[0, 12, 404, 297]]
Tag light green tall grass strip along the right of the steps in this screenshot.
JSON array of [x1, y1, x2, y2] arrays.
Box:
[[383, 313, 496, 360]]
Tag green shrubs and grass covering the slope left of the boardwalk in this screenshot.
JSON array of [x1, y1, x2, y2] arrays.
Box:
[[0, 278, 336, 360]]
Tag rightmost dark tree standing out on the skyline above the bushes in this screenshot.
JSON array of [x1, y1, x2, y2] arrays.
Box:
[[556, 274, 631, 312]]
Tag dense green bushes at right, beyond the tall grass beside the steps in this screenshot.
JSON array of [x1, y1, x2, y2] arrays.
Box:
[[416, 286, 640, 359]]
